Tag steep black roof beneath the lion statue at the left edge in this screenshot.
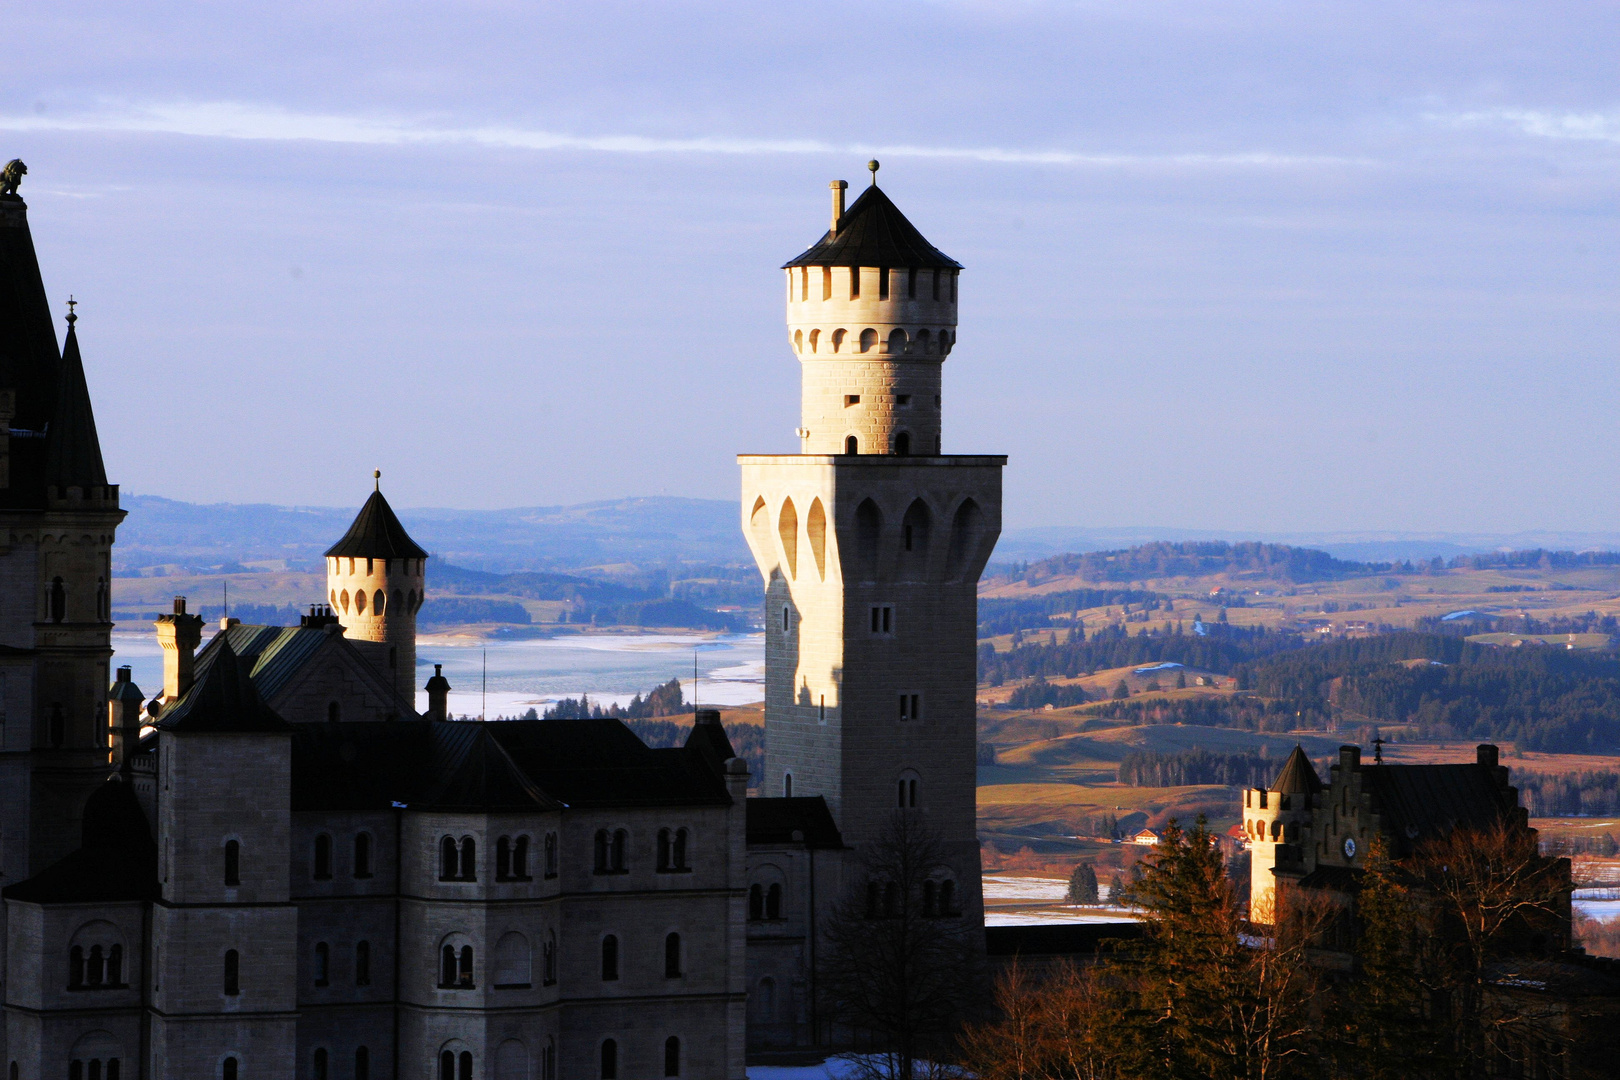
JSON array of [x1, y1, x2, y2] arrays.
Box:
[[0, 196, 62, 508]]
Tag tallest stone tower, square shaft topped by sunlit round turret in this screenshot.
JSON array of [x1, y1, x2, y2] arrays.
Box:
[[739, 173, 1006, 920]]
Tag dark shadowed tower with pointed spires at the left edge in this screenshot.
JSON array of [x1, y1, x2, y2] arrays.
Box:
[[0, 177, 125, 886]]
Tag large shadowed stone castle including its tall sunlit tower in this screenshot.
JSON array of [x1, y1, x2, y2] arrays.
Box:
[[0, 165, 1004, 1080]]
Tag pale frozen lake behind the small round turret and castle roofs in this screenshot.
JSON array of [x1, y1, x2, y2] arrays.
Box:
[[112, 628, 765, 717]]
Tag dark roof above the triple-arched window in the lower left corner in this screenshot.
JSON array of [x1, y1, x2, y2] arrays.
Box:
[[5, 779, 159, 904]]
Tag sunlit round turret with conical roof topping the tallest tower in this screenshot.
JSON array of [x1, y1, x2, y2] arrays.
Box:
[[782, 170, 962, 455]]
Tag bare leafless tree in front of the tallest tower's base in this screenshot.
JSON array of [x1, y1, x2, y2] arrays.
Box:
[[818, 810, 983, 1080]]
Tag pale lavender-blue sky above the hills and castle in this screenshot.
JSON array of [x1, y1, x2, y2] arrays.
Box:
[[0, 0, 1620, 534]]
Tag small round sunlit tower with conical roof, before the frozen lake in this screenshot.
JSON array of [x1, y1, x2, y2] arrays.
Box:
[[326, 473, 428, 719]]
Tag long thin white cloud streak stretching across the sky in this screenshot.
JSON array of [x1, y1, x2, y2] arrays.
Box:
[[0, 102, 1371, 168]]
